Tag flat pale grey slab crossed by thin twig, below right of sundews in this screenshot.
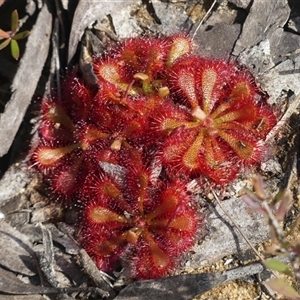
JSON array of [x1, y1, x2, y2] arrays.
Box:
[[190, 198, 269, 268]]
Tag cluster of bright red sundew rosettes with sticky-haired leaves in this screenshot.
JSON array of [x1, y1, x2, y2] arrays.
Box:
[[31, 34, 276, 279]]
